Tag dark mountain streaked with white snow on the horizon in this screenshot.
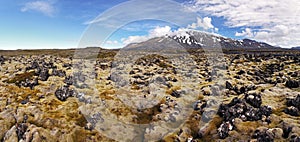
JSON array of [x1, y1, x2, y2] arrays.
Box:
[[125, 31, 278, 49]]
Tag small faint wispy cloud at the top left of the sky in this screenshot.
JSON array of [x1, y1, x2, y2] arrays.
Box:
[[21, 1, 55, 16]]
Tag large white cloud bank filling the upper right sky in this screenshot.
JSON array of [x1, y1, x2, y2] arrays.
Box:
[[187, 0, 300, 47]]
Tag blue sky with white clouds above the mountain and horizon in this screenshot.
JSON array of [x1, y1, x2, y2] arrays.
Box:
[[0, 0, 300, 50]]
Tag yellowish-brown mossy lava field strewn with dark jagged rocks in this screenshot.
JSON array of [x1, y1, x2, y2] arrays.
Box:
[[0, 49, 300, 142]]
